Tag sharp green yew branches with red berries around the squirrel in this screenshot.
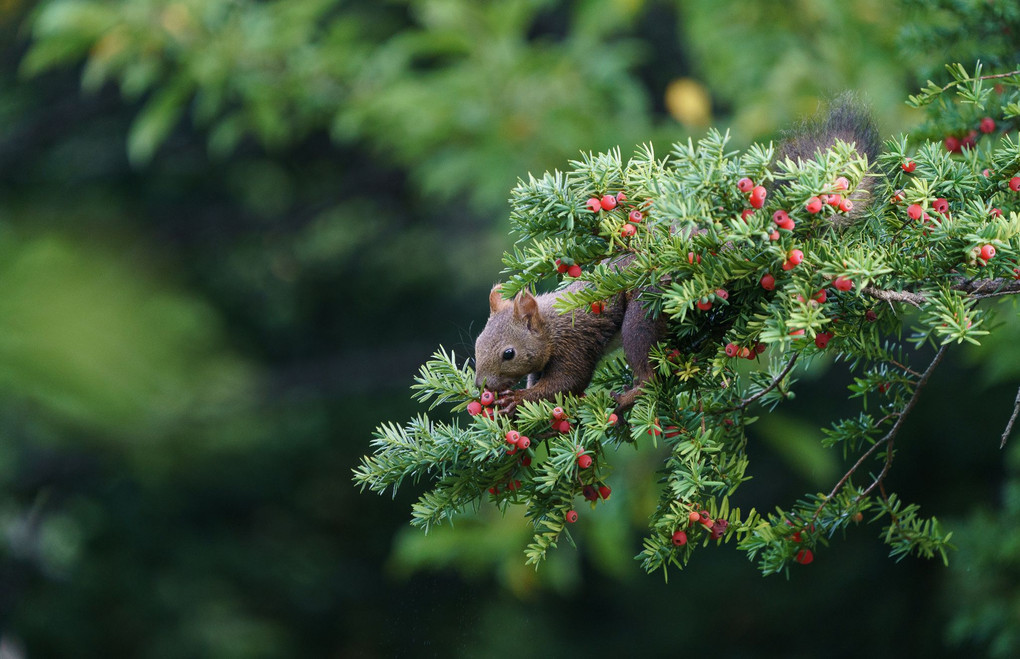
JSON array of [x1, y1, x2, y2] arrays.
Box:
[[355, 66, 1020, 574]]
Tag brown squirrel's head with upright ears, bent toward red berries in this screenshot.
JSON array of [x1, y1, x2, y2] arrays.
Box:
[[474, 284, 552, 392]]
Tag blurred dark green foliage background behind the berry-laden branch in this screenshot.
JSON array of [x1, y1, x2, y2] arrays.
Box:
[[0, 0, 1020, 659]]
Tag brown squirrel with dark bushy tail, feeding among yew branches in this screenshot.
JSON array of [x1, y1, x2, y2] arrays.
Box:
[[474, 94, 878, 415]]
